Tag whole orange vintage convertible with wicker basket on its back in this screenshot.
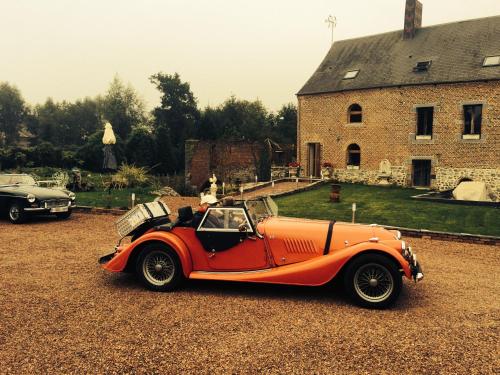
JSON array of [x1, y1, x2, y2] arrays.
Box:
[[99, 198, 423, 308]]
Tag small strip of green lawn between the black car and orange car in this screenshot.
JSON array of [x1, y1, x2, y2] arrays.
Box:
[[76, 187, 156, 212]]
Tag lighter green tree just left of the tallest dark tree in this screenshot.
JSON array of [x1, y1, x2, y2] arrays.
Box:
[[97, 76, 146, 139]]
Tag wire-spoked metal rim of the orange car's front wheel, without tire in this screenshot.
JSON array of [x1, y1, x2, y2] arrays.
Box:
[[354, 263, 394, 302]]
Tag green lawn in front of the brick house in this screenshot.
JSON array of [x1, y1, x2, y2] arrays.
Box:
[[276, 184, 500, 236]]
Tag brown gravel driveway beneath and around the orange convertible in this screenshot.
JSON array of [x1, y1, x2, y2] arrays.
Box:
[[0, 214, 500, 374]]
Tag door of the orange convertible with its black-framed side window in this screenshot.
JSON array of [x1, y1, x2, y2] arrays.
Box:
[[196, 207, 268, 271]]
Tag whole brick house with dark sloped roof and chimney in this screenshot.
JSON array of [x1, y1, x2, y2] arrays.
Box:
[[297, 0, 500, 198]]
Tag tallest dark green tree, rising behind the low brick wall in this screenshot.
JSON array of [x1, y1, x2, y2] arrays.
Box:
[[150, 73, 200, 172]]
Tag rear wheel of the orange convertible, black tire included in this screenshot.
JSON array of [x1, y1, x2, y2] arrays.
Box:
[[135, 243, 184, 292]]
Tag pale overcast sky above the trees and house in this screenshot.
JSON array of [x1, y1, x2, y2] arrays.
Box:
[[0, 0, 500, 111]]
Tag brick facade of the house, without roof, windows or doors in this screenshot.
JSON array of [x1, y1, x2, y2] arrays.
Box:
[[297, 81, 500, 200]]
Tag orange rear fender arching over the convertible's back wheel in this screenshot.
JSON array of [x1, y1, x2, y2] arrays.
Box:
[[102, 231, 193, 277]]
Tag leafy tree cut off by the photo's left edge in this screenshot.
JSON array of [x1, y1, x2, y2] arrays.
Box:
[[0, 82, 26, 145]]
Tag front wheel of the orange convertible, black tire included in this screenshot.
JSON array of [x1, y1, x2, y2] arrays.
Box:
[[344, 254, 403, 309]]
